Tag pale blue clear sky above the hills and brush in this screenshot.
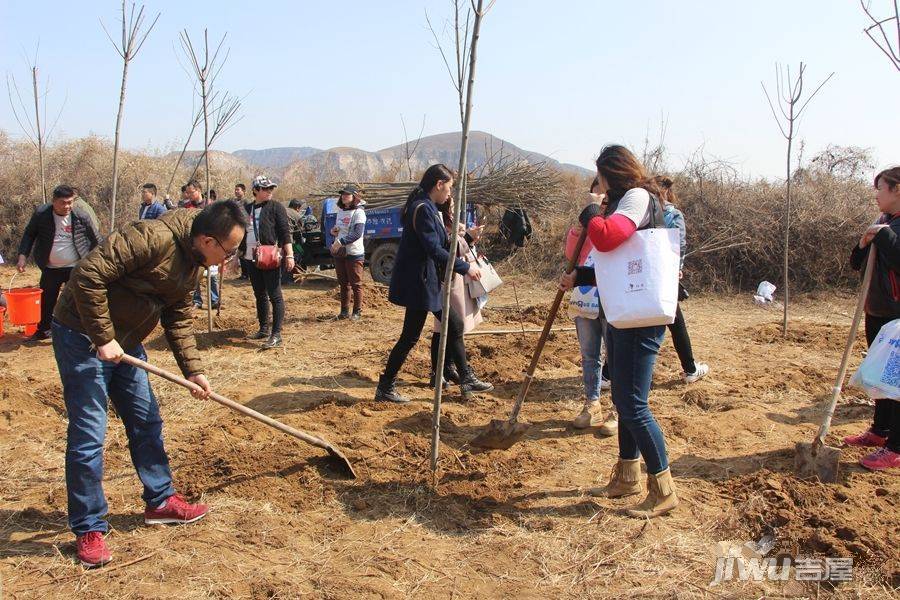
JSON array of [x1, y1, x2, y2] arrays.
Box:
[[0, 0, 900, 177]]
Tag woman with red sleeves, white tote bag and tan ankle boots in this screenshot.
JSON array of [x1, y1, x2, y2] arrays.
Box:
[[560, 145, 678, 518]]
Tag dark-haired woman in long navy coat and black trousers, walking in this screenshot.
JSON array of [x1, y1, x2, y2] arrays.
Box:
[[375, 164, 494, 403]]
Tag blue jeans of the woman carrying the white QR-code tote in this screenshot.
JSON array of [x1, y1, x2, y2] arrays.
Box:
[[606, 325, 669, 475]]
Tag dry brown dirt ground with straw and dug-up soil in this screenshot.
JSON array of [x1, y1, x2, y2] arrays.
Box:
[[0, 269, 900, 599]]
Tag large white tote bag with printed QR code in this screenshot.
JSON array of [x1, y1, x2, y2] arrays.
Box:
[[591, 227, 681, 329]]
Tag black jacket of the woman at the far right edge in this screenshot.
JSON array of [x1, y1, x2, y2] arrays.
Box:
[[850, 215, 900, 319]]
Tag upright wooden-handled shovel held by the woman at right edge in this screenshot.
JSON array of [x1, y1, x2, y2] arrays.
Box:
[[794, 243, 875, 483]]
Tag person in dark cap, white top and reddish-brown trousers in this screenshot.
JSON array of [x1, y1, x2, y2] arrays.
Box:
[[330, 184, 366, 321]]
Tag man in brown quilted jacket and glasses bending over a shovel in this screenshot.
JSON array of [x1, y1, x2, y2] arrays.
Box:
[[52, 202, 247, 567]]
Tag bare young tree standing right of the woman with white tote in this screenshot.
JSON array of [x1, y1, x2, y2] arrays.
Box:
[[760, 62, 834, 336]]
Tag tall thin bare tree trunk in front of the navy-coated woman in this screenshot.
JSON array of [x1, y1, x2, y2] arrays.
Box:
[[429, 0, 494, 475]]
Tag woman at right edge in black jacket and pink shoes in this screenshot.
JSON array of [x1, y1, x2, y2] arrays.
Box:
[[844, 167, 900, 471]]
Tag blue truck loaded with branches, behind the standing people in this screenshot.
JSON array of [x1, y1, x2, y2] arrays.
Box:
[[300, 198, 475, 284]]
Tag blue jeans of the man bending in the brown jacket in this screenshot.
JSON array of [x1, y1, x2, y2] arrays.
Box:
[[52, 321, 175, 535]]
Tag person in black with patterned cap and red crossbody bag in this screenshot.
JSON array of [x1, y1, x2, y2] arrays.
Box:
[[240, 175, 295, 349]]
